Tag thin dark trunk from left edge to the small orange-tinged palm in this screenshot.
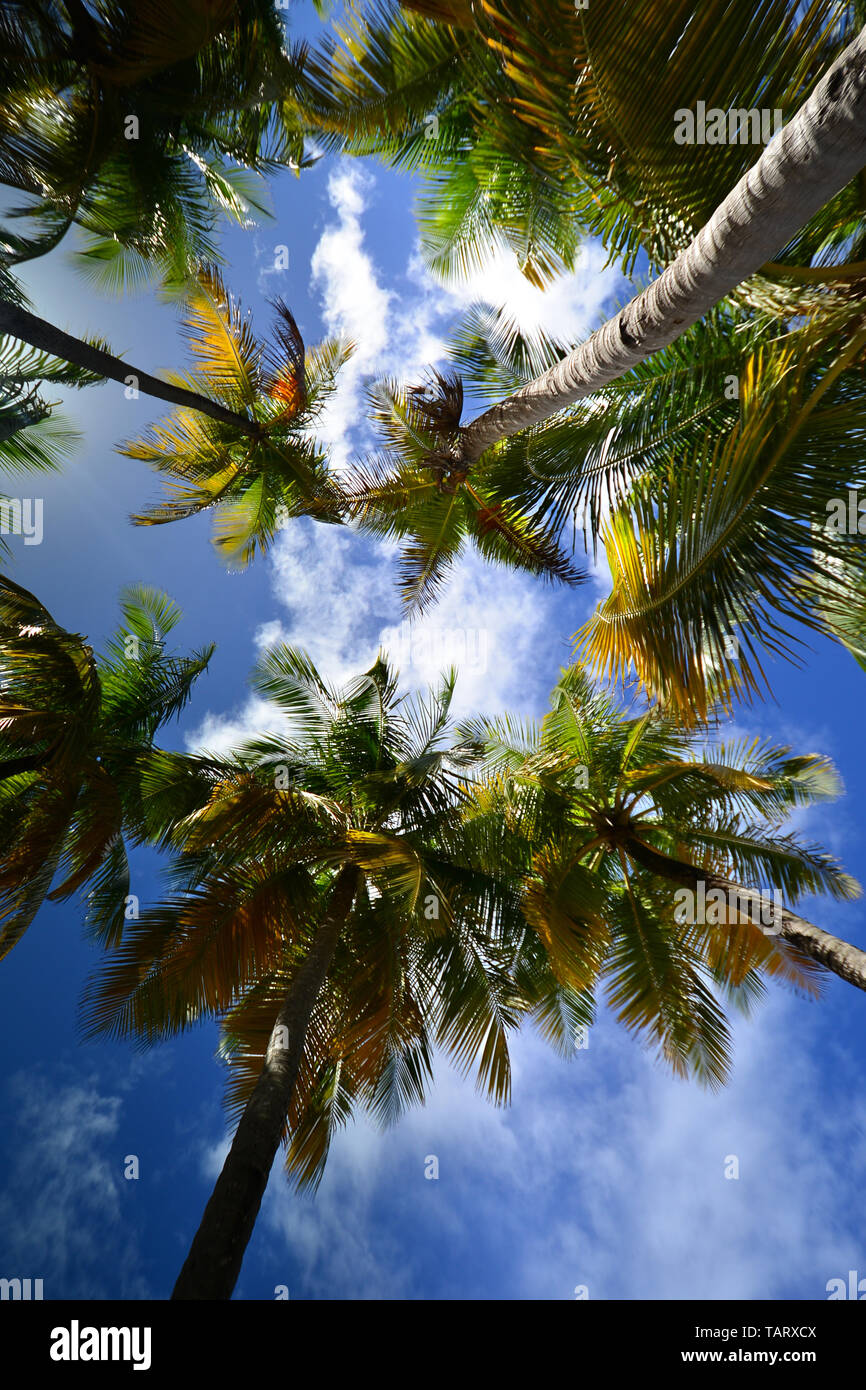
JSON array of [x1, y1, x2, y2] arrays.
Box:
[[0, 299, 259, 434]]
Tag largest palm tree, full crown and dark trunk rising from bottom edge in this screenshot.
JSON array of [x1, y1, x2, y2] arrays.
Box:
[[79, 648, 561, 1298]]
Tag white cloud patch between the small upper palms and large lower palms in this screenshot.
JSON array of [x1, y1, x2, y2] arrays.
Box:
[[186, 520, 591, 752]]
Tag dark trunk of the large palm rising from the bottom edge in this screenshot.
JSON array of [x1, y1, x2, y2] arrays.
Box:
[[171, 865, 359, 1300]]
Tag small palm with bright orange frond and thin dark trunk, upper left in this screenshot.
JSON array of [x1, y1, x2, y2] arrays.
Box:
[[0, 267, 352, 563]]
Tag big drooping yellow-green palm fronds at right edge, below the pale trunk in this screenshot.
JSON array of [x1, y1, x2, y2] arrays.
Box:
[[577, 316, 866, 721]]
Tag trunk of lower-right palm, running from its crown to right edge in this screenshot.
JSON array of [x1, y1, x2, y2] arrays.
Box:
[[623, 837, 866, 990]]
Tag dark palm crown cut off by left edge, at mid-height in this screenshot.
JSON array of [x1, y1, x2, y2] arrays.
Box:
[[0, 577, 213, 956]]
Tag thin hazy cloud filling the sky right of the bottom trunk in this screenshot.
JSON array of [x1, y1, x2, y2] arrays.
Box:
[[245, 995, 866, 1300]]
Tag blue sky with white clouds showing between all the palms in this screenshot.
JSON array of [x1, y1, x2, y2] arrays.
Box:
[[0, 2, 866, 1300]]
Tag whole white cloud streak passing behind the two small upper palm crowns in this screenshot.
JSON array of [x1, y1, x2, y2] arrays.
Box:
[[188, 161, 617, 751]]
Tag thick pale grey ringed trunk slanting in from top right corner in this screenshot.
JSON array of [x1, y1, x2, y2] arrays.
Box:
[[459, 29, 866, 466]]
